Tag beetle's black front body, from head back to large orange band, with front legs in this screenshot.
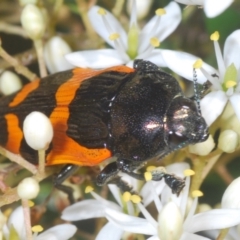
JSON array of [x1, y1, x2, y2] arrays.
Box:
[[56, 60, 208, 197]]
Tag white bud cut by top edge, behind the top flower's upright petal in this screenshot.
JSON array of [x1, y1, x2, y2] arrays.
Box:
[[127, 0, 153, 19]]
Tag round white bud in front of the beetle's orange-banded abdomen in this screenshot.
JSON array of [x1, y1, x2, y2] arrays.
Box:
[[23, 112, 53, 150]]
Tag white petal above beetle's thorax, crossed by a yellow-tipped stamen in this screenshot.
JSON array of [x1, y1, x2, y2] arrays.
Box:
[[161, 50, 217, 84]]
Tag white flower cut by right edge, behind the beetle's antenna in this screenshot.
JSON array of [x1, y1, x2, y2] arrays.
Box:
[[162, 30, 240, 126]]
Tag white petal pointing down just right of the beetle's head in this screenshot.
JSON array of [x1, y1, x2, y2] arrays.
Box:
[[200, 90, 227, 126]]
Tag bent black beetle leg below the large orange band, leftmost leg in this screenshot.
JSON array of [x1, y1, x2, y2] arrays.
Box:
[[53, 164, 78, 203]]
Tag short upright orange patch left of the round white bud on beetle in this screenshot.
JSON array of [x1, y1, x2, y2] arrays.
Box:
[[4, 113, 23, 154]]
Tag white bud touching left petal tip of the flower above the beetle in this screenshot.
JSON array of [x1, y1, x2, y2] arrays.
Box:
[[43, 36, 73, 73]]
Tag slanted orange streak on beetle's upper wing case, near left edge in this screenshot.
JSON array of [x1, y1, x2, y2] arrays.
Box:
[[9, 79, 40, 107]]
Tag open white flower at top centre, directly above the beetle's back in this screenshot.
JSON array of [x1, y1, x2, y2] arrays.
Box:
[[66, 1, 181, 68]]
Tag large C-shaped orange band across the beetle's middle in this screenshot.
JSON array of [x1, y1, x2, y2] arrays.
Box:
[[47, 67, 116, 166]]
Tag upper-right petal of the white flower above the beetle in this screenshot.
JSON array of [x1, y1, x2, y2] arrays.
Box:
[[138, 2, 182, 53]]
